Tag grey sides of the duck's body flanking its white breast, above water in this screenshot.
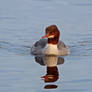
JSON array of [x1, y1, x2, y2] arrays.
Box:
[[31, 39, 70, 56]]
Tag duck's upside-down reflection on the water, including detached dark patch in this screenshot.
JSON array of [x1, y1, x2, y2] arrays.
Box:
[[35, 55, 64, 89]]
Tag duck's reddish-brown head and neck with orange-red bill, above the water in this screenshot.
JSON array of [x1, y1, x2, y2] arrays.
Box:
[[42, 25, 60, 44]]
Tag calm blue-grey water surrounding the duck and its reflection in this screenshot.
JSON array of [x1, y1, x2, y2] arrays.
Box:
[[0, 0, 92, 92]]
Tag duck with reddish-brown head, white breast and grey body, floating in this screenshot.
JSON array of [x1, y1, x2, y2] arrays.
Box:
[[31, 25, 70, 56]]
